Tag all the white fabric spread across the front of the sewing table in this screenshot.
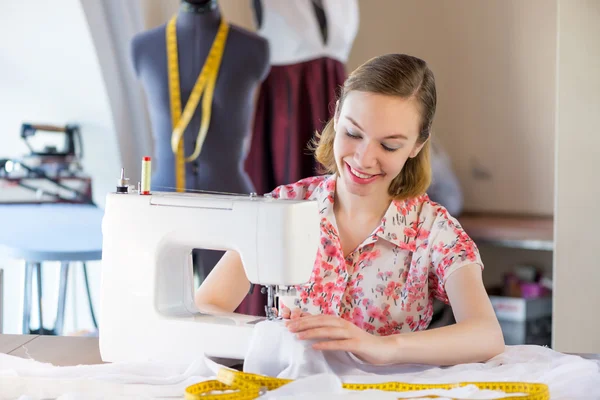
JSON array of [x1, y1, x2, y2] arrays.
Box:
[[0, 321, 600, 400]]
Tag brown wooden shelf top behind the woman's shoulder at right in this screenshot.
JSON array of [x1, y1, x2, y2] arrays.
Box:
[[457, 213, 554, 251]]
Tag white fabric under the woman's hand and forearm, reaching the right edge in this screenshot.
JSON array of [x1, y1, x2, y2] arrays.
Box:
[[244, 321, 600, 399]]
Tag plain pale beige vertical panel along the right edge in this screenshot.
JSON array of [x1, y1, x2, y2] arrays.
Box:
[[553, 0, 600, 353]]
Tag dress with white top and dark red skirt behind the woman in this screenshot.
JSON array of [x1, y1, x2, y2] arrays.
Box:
[[237, 0, 359, 315]]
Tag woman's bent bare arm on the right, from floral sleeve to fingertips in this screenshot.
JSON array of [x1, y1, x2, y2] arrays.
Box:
[[286, 264, 504, 366]]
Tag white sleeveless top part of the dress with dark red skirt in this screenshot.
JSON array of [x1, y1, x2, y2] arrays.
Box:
[[257, 0, 359, 65]]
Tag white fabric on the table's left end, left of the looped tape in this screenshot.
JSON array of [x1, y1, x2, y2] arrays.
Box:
[[0, 354, 221, 400]]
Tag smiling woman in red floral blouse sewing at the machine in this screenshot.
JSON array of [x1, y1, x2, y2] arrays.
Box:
[[196, 54, 504, 365]]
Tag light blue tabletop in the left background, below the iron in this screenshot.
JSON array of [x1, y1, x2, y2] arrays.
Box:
[[0, 203, 104, 262]]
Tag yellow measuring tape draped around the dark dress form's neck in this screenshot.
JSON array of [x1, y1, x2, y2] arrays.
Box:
[[166, 16, 229, 192]]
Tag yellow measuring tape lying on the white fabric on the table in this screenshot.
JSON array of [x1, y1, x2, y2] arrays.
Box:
[[185, 368, 550, 400]]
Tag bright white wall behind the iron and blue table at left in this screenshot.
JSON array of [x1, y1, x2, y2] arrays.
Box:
[[0, 0, 121, 333]]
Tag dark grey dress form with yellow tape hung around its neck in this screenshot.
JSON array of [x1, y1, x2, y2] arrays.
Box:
[[131, 0, 270, 290]]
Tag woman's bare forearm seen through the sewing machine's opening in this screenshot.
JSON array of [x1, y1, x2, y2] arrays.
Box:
[[195, 251, 250, 313]]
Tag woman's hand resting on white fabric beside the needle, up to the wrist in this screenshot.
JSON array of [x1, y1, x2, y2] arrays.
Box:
[[286, 315, 396, 365]]
